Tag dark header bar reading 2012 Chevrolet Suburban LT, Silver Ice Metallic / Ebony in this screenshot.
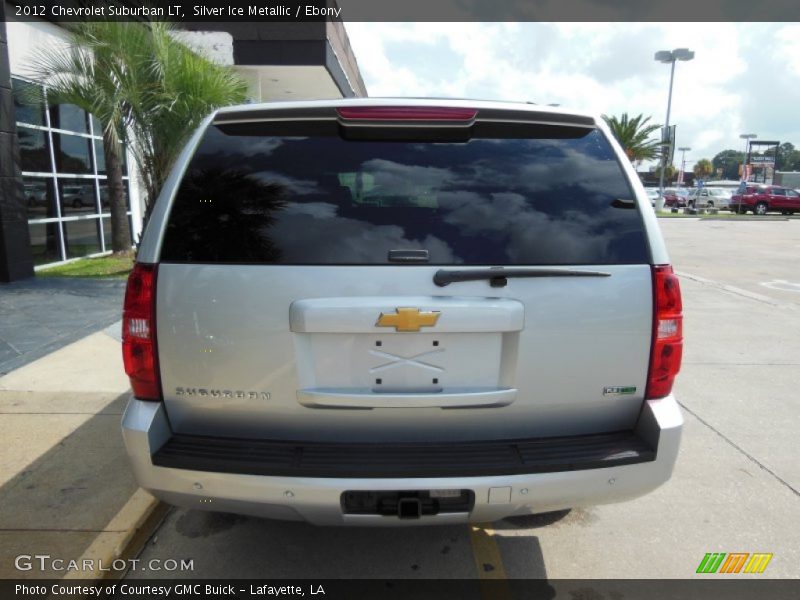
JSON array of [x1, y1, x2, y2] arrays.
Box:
[[6, 0, 797, 23]]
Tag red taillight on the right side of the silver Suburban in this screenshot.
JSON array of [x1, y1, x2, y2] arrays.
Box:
[[645, 265, 683, 400]]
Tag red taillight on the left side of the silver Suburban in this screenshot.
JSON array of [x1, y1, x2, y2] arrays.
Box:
[[122, 263, 162, 401]]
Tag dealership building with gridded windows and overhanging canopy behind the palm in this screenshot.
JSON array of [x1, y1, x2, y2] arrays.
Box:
[[0, 3, 366, 282]]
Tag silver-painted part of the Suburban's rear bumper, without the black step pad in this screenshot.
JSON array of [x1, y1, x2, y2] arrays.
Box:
[[122, 396, 683, 526]]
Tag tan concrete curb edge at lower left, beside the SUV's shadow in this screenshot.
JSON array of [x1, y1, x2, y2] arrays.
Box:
[[63, 488, 169, 580]]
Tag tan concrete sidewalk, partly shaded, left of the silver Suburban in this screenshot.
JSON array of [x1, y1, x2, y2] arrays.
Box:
[[0, 323, 158, 578]]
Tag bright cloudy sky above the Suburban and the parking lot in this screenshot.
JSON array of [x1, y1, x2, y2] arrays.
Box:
[[345, 22, 800, 170]]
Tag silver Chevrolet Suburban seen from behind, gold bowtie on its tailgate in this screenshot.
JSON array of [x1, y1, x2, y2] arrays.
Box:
[[122, 99, 683, 525]]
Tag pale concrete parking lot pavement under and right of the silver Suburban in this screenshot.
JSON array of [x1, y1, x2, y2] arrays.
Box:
[[128, 219, 800, 579]]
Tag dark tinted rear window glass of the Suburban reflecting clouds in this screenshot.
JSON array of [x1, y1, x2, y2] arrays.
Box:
[[161, 123, 649, 265]]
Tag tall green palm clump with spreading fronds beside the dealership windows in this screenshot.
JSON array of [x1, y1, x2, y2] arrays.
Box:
[[31, 21, 247, 247]]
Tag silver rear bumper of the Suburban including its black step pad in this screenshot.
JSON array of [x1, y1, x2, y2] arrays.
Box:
[[122, 396, 683, 525]]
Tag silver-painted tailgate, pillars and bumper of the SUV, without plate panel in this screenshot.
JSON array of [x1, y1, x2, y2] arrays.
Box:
[[123, 98, 682, 525]]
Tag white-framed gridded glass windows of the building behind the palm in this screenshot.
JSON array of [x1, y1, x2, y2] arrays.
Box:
[[11, 77, 132, 265]]
